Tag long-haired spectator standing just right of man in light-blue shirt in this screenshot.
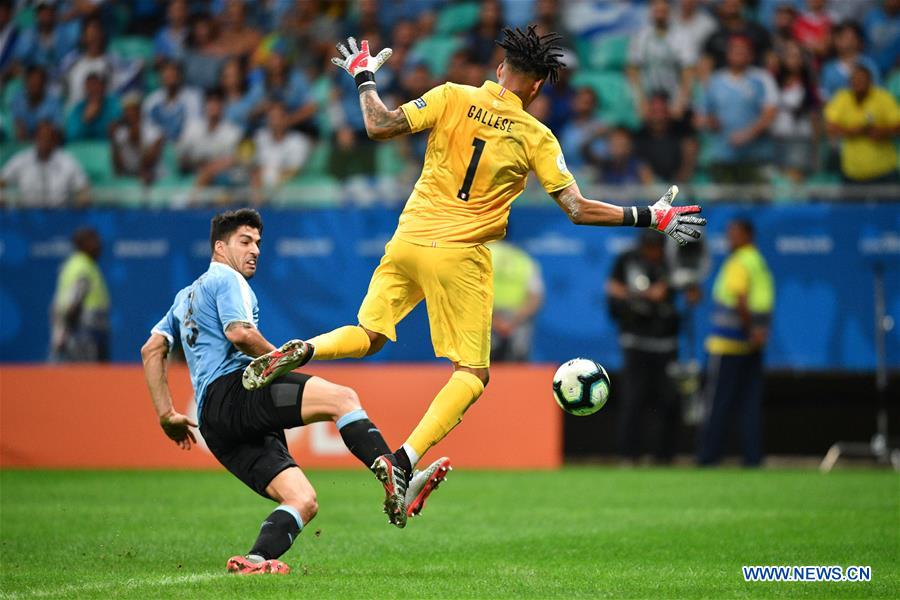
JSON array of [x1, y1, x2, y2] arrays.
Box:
[[772, 41, 820, 183]]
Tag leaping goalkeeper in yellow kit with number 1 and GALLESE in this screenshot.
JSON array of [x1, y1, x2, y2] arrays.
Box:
[[244, 27, 706, 527]]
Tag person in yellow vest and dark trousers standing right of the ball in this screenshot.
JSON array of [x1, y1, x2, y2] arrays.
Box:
[[698, 219, 775, 467]]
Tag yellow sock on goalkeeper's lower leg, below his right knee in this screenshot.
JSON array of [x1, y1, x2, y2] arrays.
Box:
[[406, 371, 484, 456]]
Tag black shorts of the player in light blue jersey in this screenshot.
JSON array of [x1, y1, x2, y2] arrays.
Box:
[[200, 369, 311, 498]]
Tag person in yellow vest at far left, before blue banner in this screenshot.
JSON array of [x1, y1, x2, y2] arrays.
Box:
[[50, 228, 109, 362]]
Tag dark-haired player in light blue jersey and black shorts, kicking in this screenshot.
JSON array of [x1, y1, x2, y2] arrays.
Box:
[[141, 209, 443, 574]]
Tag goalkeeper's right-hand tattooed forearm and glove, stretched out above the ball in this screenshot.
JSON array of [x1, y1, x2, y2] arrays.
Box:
[[551, 183, 706, 246]]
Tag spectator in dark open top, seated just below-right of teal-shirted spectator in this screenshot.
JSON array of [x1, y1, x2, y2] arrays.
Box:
[[110, 92, 164, 185]]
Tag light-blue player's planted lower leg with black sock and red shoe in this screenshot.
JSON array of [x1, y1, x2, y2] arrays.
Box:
[[225, 467, 319, 575]]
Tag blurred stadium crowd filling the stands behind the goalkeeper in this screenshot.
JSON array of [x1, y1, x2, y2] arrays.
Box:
[[0, 0, 900, 206]]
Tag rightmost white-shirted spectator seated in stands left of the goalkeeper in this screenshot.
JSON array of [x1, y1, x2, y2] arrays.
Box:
[[251, 102, 312, 199]]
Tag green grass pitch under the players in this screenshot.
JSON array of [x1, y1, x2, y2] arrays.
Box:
[[0, 468, 900, 599]]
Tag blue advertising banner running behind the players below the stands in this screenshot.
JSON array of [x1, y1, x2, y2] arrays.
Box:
[[0, 204, 900, 370]]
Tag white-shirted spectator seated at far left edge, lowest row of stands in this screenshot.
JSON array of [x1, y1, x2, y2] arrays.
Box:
[[0, 121, 90, 208]]
